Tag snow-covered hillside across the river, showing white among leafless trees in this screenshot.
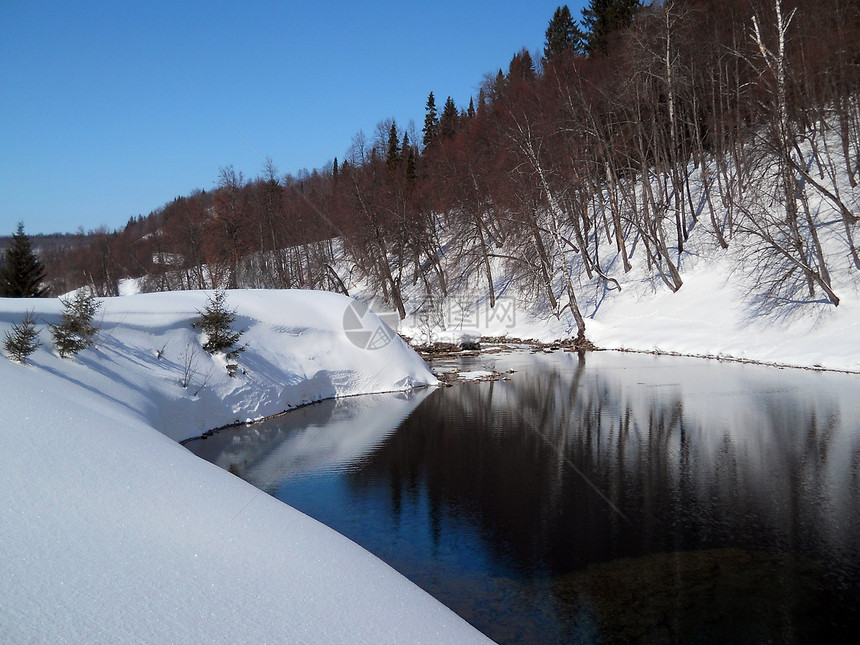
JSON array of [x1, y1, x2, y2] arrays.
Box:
[[384, 129, 860, 371]]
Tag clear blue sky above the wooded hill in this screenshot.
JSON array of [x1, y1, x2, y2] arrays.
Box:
[[0, 0, 583, 234]]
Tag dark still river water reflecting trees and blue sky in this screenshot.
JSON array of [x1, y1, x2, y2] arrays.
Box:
[[188, 352, 860, 643]]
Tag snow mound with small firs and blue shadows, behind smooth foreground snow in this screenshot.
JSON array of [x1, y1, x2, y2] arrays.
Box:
[[0, 290, 435, 440]]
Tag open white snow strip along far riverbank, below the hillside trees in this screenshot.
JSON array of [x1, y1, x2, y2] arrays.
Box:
[[399, 218, 860, 372]]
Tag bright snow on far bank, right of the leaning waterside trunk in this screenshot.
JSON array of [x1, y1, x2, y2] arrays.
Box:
[[583, 230, 860, 372]]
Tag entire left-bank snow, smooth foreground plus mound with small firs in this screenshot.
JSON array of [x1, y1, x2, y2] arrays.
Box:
[[0, 291, 485, 643]]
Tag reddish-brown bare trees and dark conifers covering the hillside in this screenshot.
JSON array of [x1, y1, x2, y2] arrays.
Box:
[[42, 0, 860, 336]]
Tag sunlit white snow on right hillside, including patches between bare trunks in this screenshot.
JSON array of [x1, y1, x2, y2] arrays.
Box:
[[390, 128, 860, 372]]
